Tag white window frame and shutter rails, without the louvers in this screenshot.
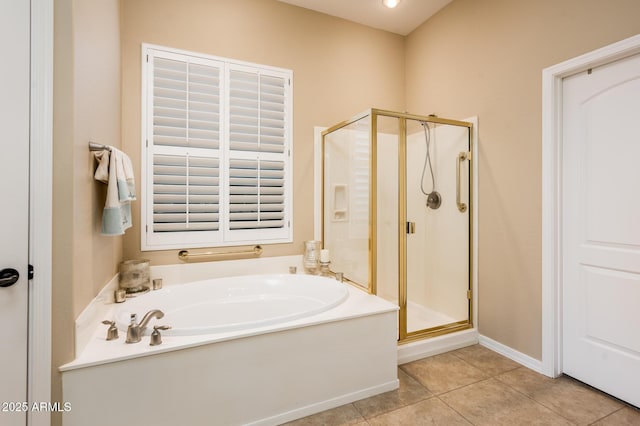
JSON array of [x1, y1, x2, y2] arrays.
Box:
[[140, 43, 293, 251]]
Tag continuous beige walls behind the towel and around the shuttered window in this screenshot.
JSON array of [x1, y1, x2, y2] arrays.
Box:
[[52, 0, 404, 424]]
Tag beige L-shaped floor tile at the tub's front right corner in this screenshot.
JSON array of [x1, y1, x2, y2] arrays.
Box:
[[353, 369, 432, 418]]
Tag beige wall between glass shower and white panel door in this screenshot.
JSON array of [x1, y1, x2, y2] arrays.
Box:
[[405, 0, 640, 359]]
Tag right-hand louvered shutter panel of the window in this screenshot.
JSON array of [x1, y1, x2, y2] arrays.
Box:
[[228, 66, 288, 240]]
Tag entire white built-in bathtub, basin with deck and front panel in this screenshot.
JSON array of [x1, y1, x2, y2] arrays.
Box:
[[60, 260, 398, 426]]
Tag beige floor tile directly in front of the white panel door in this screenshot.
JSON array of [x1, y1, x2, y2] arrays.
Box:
[[531, 377, 623, 425]]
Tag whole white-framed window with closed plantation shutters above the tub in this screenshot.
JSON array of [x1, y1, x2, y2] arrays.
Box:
[[142, 45, 293, 250]]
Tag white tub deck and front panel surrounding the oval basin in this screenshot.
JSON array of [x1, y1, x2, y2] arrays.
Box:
[[60, 256, 399, 426]]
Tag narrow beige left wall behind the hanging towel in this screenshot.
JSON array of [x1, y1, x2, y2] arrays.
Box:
[[52, 0, 122, 422]]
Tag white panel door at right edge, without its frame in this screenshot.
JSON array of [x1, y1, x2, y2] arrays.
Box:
[[562, 51, 640, 406]]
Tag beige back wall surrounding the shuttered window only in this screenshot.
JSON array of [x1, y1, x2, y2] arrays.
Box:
[[122, 0, 404, 264]]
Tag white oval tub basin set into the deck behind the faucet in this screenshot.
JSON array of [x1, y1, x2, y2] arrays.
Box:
[[115, 274, 349, 336]]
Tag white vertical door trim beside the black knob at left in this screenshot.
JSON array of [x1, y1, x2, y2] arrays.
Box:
[[27, 0, 53, 426]]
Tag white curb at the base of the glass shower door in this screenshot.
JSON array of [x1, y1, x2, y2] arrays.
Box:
[[398, 328, 478, 365]]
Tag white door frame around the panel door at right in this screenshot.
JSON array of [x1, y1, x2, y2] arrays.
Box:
[[542, 34, 640, 377]]
